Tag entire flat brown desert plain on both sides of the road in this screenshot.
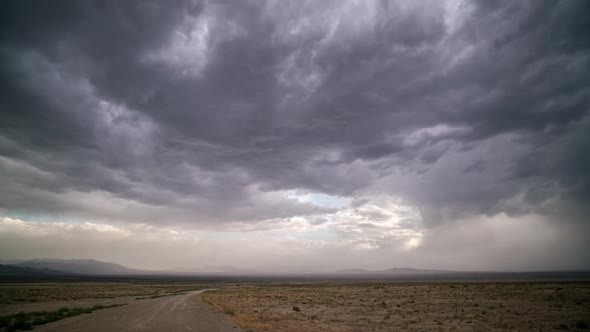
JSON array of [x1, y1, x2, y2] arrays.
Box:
[[0, 281, 590, 332]]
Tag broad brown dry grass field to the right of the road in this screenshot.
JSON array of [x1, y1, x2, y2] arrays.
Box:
[[203, 282, 590, 331]]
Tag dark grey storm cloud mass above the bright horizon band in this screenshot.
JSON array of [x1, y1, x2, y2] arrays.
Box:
[[0, 1, 590, 225]]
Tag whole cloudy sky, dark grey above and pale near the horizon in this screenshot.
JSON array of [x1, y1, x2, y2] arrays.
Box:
[[0, 0, 590, 271]]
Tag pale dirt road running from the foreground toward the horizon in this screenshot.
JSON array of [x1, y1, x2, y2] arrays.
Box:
[[35, 290, 241, 332]]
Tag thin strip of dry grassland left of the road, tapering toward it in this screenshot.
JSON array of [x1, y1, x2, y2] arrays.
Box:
[[0, 282, 206, 305]]
